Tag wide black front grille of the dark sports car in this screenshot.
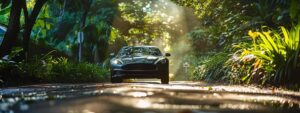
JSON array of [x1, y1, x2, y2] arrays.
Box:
[[122, 64, 156, 70]]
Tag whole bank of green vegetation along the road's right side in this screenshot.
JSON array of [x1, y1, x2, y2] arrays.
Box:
[[174, 0, 300, 89]]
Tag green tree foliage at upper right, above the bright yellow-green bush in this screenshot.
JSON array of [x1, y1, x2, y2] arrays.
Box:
[[172, 0, 300, 50]]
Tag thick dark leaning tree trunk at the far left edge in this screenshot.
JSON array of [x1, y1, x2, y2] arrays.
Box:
[[0, 0, 22, 58]]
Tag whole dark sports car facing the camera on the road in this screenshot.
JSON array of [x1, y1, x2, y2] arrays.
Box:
[[110, 46, 171, 84]]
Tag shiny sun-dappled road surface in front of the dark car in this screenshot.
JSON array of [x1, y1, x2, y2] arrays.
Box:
[[0, 81, 300, 113]]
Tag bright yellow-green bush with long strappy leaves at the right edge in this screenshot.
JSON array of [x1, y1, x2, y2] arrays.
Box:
[[242, 25, 300, 85]]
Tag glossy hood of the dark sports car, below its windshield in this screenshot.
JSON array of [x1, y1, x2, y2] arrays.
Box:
[[116, 56, 163, 64]]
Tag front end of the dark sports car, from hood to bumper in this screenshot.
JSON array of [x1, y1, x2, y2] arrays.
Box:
[[110, 55, 169, 79]]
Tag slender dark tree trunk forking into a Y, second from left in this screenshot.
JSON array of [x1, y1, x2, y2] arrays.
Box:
[[23, 0, 47, 60]]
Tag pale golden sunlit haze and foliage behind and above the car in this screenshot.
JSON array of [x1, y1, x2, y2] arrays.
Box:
[[113, 0, 198, 80]]
